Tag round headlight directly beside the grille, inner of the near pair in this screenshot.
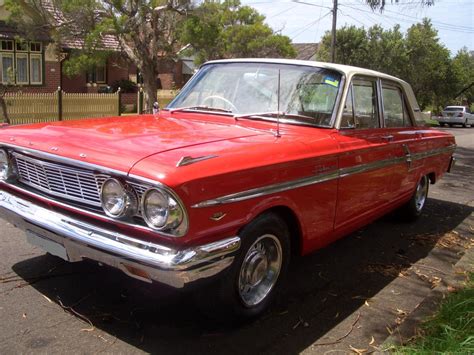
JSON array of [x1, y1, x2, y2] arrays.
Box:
[[100, 178, 138, 218]]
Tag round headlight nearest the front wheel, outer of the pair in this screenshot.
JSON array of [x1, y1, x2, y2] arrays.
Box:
[[142, 188, 184, 230]]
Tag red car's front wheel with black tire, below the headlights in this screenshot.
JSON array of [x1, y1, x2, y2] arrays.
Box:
[[197, 213, 290, 320]]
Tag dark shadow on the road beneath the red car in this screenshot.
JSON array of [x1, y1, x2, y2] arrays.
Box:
[[13, 199, 474, 354]]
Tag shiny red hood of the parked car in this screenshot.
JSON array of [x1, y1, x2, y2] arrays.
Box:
[[0, 115, 268, 172]]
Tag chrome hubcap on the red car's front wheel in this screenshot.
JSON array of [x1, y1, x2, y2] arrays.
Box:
[[238, 234, 282, 307]]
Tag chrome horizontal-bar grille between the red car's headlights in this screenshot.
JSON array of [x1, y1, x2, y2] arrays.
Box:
[[12, 152, 108, 207]]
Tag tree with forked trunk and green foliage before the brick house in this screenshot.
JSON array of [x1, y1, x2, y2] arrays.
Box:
[[7, 0, 192, 107]]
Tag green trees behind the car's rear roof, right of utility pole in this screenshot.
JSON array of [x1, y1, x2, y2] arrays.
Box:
[[318, 19, 468, 109]]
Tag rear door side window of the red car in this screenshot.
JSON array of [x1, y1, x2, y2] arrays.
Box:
[[382, 83, 411, 127]]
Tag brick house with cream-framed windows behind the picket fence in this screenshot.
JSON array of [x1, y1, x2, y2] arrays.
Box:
[[0, 0, 190, 104]]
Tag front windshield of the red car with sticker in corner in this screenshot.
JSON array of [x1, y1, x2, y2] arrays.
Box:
[[167, 63, 341, 126]]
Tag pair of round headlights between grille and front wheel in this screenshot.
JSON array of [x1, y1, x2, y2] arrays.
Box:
[[100, 178, 185, 234]]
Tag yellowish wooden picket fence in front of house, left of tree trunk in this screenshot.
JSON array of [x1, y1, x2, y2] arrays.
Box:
[[0, 90, 120, 125]]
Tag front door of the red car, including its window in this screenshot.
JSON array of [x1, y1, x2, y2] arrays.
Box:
[[335, 76, 396, 230]]
